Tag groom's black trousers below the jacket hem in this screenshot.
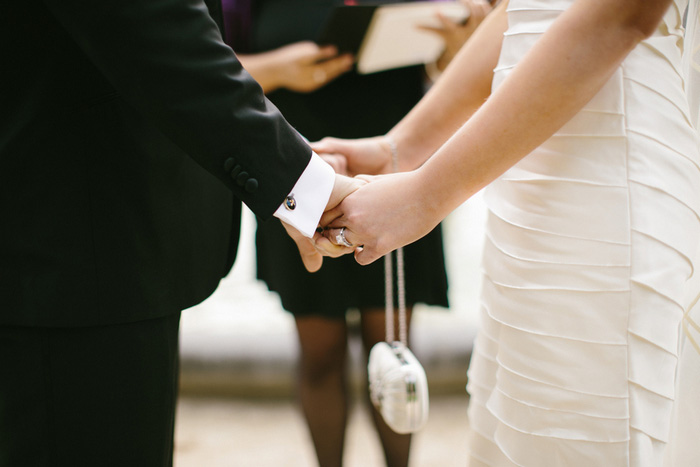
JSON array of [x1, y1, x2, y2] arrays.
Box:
[[0, 313, 180, 467]]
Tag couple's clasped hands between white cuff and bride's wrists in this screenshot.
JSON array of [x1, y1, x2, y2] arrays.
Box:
[[300, 138, 441, 269]]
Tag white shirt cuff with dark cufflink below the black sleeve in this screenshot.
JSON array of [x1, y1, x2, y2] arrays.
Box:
[[274, 153, 335, 238]]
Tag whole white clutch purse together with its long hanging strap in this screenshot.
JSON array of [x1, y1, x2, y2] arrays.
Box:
[[367, 248, 429, 434]]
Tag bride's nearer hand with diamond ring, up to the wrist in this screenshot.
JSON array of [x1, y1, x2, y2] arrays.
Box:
[[316, 172, 443, 265]]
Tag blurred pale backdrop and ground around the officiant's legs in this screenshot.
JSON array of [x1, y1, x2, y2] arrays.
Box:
[[175, 195, 485, 467]]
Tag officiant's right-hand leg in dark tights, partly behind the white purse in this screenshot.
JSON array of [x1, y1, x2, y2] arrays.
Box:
[[360, 308, 411, 467]]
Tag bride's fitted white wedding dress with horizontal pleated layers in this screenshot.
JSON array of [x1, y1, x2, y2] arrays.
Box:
[[468, 0, 700, 467]]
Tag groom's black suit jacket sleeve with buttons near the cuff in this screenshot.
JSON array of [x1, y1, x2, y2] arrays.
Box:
[[40, 0, 311, 218]]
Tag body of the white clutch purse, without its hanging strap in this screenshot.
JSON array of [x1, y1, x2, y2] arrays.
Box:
[[367, 342, 429, 434]]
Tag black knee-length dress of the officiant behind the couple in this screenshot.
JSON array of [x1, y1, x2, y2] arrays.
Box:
[[251, 0, 447, 318]]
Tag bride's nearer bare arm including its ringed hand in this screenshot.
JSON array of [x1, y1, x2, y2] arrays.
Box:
[[322, 0, 670, 264]]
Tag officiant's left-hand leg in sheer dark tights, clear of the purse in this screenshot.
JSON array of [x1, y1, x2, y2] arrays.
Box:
[[296, 316, 348, 467]]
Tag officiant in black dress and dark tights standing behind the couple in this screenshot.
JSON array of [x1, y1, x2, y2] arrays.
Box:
[[222, 0, 490, 467]]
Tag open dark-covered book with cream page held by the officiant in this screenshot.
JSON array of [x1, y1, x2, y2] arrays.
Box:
[[317, 2, 469, 73]]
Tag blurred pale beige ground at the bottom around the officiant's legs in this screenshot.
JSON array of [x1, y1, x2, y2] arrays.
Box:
[[175, 395, 476, 467]]
